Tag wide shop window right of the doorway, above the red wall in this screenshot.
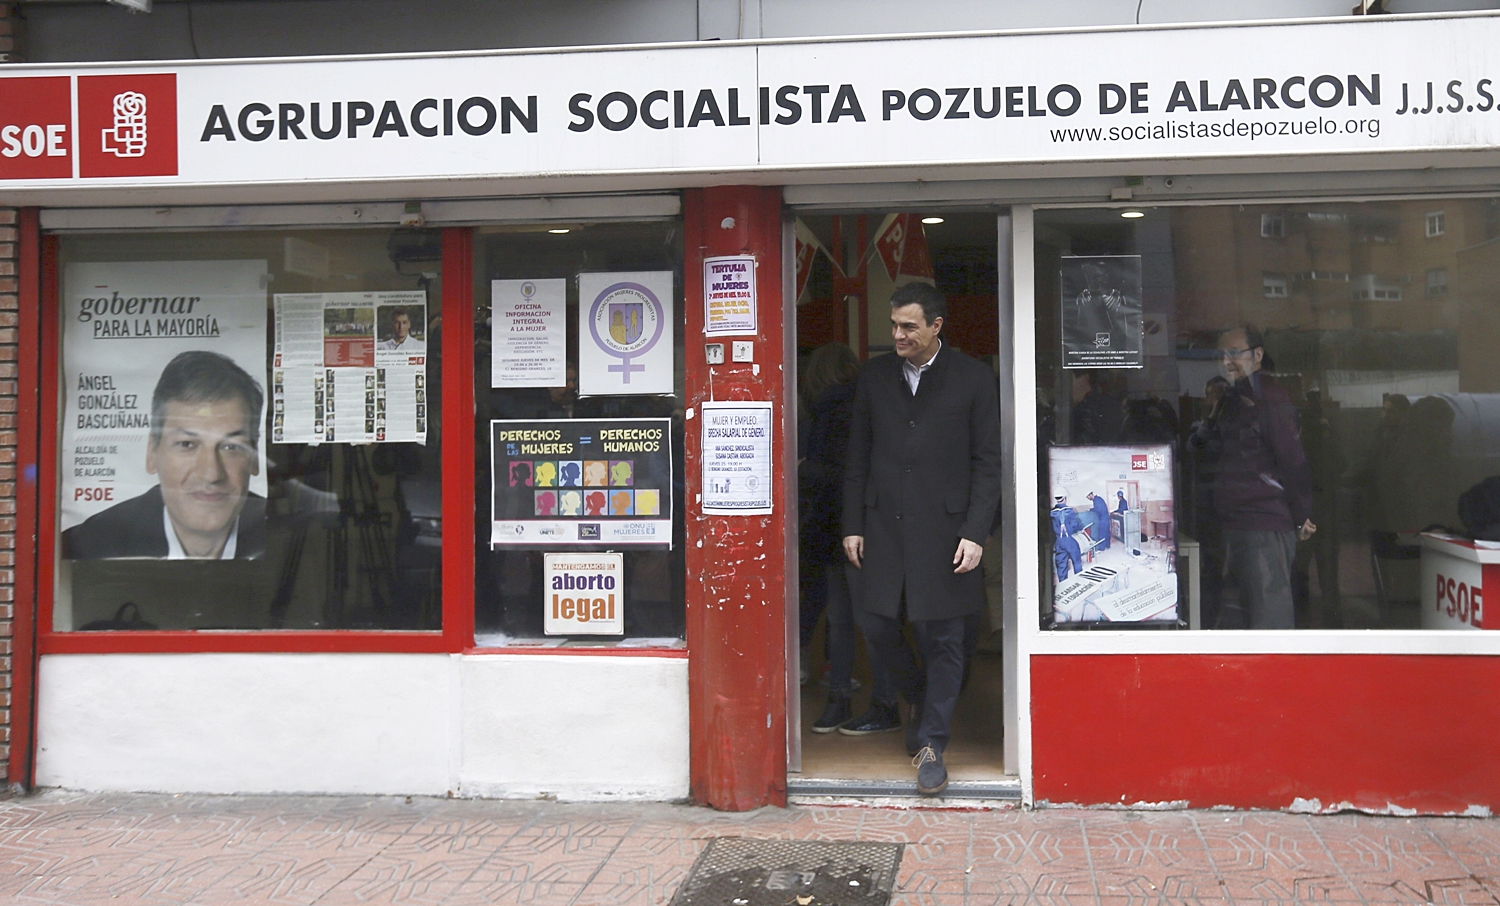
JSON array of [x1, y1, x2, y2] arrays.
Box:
[[1035, 198, 1500, 630]]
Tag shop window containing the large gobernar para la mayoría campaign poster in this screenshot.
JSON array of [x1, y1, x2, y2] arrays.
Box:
[[53, 230, 443, 632]]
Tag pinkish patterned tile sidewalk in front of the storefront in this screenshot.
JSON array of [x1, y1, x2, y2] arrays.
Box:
[[0, 792, 1500, 906]]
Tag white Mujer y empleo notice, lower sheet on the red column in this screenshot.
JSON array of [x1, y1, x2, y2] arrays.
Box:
[[702, 401, 773, 516]]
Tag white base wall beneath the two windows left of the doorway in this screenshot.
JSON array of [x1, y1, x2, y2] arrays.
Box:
[[36, 654, 689, 800]]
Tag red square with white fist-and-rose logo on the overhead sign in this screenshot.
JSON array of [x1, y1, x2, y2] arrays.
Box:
[[78, 72, 177, 177]]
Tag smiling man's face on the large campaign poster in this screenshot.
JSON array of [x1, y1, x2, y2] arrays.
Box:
[[146, 399, 261, 536]]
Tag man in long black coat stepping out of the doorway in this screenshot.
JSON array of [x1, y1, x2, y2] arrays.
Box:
[[843, 284, 1002, 795]]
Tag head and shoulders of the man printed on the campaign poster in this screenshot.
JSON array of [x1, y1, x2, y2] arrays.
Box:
[[63, 350, 266, 560]]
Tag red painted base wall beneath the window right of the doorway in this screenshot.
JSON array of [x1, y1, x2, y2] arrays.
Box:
[[1032, 654, 1500, 813]]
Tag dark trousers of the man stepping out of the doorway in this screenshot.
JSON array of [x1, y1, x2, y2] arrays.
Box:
[[855, 609, 971, 752]]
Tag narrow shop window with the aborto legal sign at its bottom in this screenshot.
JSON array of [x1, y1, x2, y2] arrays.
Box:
[[474, 222, 686, 647]]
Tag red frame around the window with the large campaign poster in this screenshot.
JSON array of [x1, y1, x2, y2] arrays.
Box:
[[17, 227, 687, 657]]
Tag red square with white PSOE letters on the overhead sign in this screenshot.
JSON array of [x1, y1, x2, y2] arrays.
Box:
[[0, 75, 74, 180]]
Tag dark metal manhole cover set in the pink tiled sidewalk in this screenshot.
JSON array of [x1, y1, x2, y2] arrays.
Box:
[[672, 837, 902, 906]]
